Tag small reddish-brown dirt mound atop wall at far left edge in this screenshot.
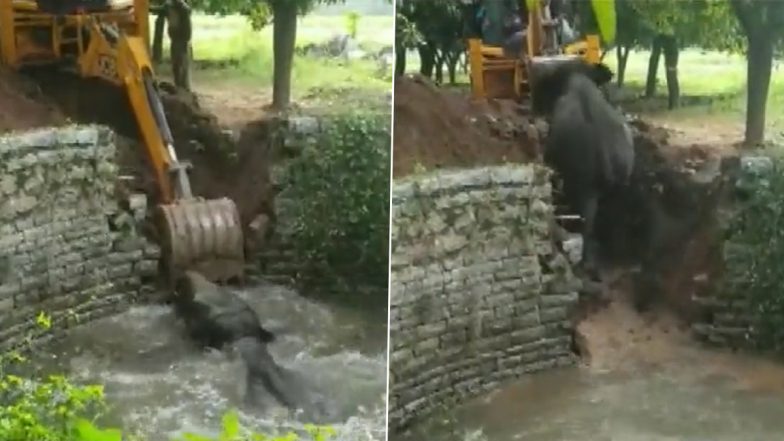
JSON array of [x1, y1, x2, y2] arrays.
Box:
[[0, 68, 65, 132]]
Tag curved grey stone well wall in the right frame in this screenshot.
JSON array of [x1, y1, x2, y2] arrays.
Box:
[[389, 164, 578, 432]]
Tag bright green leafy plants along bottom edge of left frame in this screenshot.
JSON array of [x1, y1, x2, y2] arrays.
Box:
[[0, 313, 335, 441]]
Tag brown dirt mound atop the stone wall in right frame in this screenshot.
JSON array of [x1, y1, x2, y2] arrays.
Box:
[[393, 76, 537, 177]]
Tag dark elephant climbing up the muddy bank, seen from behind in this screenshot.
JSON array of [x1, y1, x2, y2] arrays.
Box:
[[532, 61, 634, 280]]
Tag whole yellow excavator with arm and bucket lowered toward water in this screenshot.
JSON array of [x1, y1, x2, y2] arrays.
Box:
[[0, 0, 245, 281]]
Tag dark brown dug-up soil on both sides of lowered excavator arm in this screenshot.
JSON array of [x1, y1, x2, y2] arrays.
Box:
[[0, 70, 272, 237]]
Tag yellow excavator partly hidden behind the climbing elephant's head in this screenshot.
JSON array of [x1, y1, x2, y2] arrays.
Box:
[[468, 0, 602, 99]]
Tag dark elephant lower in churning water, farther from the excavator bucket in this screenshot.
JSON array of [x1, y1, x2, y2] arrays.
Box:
[[234, 337, 335, 424]]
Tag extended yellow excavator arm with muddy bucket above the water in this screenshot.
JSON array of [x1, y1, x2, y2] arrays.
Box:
[[73, 16, 244, 280]]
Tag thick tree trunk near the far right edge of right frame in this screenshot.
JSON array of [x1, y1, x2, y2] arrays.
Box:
[[744, 32, 773, 146]]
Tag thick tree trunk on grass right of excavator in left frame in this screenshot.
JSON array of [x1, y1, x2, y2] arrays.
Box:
[[272, 1, 297, 110]]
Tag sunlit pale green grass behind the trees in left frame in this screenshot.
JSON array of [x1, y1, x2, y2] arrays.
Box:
[[161, 14, 394, 105]]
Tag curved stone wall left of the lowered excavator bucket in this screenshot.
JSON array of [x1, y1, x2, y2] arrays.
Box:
[[0, 126, 159, 351]]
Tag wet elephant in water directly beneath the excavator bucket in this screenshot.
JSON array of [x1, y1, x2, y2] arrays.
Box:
[[174, 271, 275, 350]]
